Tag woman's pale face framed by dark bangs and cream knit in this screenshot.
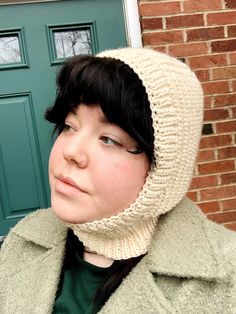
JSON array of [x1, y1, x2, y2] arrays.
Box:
[[49, 105, 149, 223]]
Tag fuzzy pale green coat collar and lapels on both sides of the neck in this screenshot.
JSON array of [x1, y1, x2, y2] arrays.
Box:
[[0, 199, 235, 314]]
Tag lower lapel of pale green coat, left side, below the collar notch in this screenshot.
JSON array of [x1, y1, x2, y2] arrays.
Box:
[[4, 248, 62, 314]]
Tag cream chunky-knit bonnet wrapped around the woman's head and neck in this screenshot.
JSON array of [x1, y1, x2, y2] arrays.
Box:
[[69, 48, 203, 260]]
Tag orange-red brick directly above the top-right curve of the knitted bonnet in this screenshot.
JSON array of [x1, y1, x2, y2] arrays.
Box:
[[169, 43, 208, 57]]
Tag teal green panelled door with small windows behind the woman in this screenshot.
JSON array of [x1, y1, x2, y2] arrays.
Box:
[[0, 0, 127, 239]]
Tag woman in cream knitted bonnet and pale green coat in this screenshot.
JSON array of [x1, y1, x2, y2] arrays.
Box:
[[0, 48, 236, 314]]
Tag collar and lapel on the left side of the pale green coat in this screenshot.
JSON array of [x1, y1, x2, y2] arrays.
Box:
[[3, 210, 67, 314]]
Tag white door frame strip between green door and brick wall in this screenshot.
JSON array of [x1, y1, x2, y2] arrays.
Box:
[[123, 0, 143, 48]]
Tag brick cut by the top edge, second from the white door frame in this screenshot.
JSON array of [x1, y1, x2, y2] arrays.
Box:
[[183, 0, 222, 12]]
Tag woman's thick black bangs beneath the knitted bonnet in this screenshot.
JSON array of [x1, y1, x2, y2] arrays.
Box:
[[45, 56, 154, 162]]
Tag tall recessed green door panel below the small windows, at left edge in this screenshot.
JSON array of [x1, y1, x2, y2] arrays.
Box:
[[0, 94, 46, 232]]
